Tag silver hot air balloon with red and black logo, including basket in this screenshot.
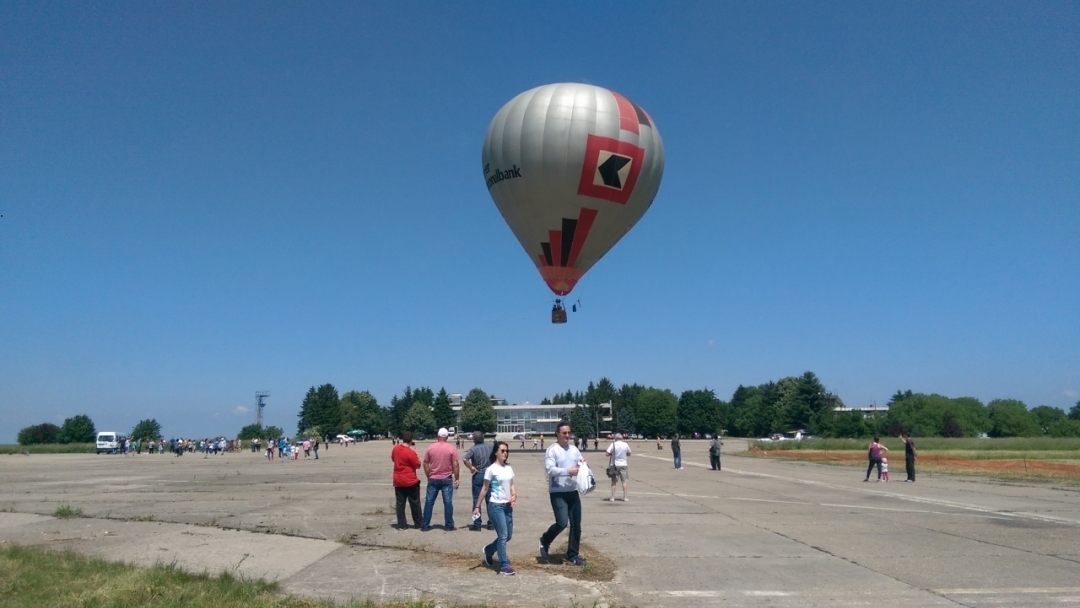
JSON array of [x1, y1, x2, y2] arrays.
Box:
[[483, 83, 664, 323]]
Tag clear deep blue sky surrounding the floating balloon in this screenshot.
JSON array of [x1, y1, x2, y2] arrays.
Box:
[[0, 1, 1080, 443]]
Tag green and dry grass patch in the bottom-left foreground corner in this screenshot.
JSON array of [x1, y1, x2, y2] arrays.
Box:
[[0, 546, 435, 608]]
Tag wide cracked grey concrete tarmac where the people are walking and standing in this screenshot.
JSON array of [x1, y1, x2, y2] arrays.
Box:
[[0, 440, 1080, 608]]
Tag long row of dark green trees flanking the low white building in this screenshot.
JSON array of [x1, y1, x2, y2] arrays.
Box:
[[298, 371, 1080, 437]]
